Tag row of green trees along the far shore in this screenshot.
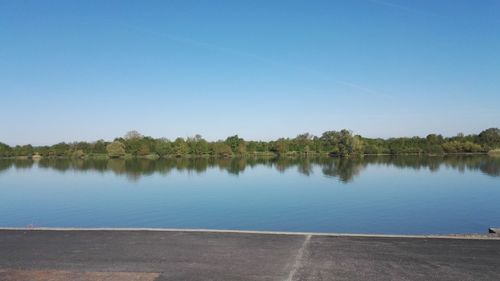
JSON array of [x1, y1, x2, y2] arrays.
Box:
[[0, 128, 500, 159]]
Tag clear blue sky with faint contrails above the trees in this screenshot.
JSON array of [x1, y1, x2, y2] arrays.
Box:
[[0, 0, 500, 145]]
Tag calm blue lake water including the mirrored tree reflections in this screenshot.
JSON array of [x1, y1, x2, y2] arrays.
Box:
[[0, 156, 500, 234]]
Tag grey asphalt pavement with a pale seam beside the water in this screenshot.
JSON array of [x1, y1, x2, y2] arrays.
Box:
[[0, 230, 500, 281]]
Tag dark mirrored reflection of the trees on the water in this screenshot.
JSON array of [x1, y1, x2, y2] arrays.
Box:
[[0, 155, 500, 183]]
